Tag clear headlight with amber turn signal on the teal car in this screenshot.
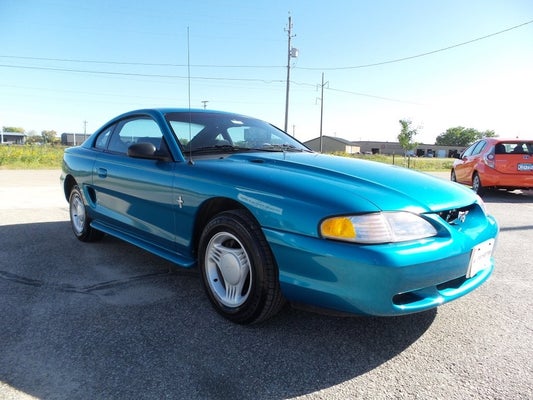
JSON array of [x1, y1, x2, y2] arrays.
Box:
[[320, 212, 437, 243]]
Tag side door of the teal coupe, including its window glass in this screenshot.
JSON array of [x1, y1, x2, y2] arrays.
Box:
[[92, 116, 175, 249]]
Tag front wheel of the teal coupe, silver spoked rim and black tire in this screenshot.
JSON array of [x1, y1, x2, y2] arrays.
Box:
[[198, 210, 285, 324]]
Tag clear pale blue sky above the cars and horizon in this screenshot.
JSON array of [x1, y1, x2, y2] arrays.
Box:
[[0, 0, 533, 143]]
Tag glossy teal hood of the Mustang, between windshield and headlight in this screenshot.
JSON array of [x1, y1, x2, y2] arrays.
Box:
[[225, 152, 478, 213]]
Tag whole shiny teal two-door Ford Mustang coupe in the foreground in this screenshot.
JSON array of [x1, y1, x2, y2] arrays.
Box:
[[61, 109, 498, 324]]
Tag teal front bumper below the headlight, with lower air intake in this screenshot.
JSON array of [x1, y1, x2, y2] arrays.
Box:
[[264, 212, 498, 316]]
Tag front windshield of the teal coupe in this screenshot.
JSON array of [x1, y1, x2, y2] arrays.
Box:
[[166, 111, 310, 154]]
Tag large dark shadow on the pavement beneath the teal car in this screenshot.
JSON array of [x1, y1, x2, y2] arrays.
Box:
[[0, 222, 437, 399]]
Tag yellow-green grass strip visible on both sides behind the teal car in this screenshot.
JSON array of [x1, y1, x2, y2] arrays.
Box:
[[0, 145, 453, 172]]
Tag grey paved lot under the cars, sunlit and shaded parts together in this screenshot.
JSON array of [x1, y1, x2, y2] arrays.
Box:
[[0, 170, 533, 399]]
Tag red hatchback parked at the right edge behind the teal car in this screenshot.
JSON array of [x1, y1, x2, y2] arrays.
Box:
[[451, 138, 533, 194]]
